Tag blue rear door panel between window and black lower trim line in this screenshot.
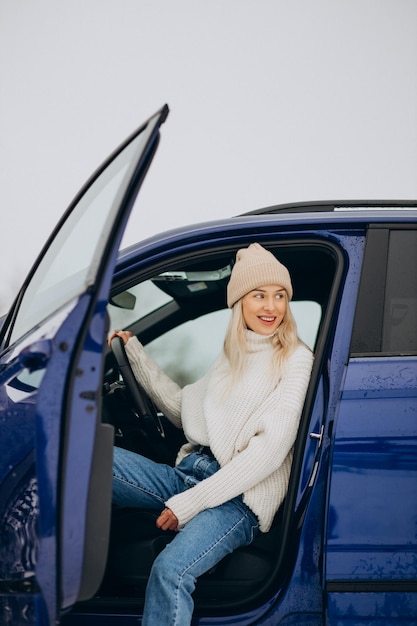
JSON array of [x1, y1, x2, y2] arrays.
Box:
[[327, 357, 417, 581]]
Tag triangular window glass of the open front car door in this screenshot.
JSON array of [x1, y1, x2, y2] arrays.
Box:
[[9, 116, 164, 343]]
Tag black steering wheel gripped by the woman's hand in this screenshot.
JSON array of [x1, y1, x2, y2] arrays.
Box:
[[111, 336, 165, 438]]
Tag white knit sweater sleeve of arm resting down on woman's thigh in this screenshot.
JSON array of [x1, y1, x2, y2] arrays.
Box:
[[165, 346, 313, 527]]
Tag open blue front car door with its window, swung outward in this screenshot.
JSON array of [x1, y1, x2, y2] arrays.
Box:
[[0, 106, 168, 626]]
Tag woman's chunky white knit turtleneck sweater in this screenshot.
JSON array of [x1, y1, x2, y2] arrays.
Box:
[[126, 330, 313, 532]]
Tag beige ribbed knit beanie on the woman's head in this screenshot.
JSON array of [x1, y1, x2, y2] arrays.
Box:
[[227, 243, 292, 308]]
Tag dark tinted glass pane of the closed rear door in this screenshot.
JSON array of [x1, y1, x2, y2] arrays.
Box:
[[382, 230, 417, 353]]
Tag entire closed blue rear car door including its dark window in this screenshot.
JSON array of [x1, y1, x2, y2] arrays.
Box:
[[326, 225, 417, 626]]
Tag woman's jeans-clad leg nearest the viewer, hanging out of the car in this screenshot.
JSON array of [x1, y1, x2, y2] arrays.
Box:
[[142, 498, 258, 626]]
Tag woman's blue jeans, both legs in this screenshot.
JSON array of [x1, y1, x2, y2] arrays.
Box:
[[113, 448, 259, 626]]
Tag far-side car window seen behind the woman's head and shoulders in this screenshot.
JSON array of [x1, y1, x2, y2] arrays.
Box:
[[146, 301, 321, 387]]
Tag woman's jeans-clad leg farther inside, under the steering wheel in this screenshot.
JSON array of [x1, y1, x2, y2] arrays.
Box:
[[113, 448, 184, 509]]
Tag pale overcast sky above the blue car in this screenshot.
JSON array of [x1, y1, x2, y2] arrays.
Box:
[[0, 0, 417, 312]]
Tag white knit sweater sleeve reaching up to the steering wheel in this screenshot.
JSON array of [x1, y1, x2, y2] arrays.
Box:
[[125, 337, 182, 428]]
